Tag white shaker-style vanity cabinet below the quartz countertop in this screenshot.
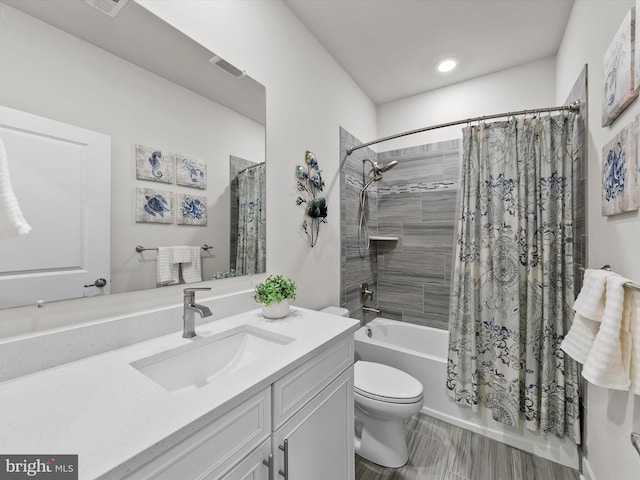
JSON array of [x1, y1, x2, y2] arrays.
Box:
[[120, 335, 354, 480]]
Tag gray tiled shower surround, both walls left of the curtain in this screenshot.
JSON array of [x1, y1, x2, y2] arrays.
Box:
[[340, 129, 461, 329]]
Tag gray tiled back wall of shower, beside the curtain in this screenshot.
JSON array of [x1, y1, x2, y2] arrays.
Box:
[[377, 140, 462, 329]]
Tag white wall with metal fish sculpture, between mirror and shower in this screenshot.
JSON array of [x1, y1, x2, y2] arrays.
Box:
[[134, 0, 376, 308]]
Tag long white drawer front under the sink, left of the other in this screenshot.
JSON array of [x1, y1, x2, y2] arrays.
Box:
[[127, 388, 271, 480]]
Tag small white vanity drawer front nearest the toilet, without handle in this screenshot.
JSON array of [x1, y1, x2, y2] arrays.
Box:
[[273, 335, 354, 431]]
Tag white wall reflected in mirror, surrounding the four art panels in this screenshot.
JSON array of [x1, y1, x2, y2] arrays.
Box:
[[0, 4, 265, 292]]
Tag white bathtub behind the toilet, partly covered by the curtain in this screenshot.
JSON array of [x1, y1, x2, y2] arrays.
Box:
[[355, 318, 579, 469]]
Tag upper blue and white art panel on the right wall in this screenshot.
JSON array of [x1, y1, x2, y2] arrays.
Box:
[[602, 8, 638, 127]]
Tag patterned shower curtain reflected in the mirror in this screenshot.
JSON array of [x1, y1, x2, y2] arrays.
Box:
[[236, 163, 267, 275]]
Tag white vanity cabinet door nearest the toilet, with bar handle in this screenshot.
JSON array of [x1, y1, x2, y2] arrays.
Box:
[[273, 365, 354, 480]]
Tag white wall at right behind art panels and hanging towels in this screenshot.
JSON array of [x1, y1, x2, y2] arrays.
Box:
[[556, 0, 640, 480]]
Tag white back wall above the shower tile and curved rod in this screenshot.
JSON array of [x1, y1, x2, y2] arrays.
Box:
[[372, 57, 556, 148]]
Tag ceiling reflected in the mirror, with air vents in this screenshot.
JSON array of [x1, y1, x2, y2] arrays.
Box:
[[0, 0, 266, 125]]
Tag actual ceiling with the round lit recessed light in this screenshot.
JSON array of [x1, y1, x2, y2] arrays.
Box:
[[284, 0, 573, 105]]
